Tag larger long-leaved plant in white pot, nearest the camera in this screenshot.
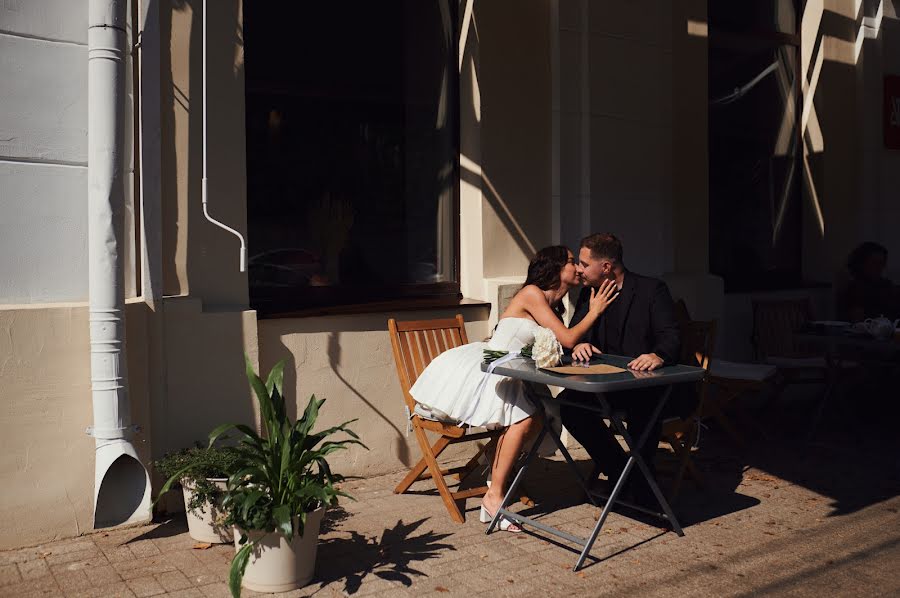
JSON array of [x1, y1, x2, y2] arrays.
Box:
[[216, 360, 365, 596]]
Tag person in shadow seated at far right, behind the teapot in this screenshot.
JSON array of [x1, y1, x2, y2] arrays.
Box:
[[838, 241, 900, 322]]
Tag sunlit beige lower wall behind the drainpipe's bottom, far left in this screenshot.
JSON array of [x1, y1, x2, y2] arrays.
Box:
[[0, 302, 150, 549]]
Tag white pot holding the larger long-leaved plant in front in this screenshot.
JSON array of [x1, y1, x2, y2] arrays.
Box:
[[234, 507, 325, 593]]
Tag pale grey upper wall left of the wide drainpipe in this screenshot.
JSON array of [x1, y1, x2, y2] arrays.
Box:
[[0, 0, 87, 304]]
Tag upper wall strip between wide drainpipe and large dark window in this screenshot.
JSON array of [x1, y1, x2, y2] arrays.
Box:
[[161, 0, 247, 304]]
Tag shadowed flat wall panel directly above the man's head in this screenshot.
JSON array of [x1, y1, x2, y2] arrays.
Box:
[[588, 1, 673, 274]]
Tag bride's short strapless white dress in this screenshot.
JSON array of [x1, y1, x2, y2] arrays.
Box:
[[409, 318, 549, 429]]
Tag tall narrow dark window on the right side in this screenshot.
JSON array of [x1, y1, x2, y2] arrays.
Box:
[[709, 0, 803, 291]]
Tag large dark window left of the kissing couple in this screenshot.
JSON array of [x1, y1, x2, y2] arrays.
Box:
[[244, 0, 459, 314]]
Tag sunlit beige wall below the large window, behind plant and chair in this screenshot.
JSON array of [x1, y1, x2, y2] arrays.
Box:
[[253, 307, 489, 475]]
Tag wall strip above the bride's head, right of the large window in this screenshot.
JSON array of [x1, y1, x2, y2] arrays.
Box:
[[460, 0, 553, 304]]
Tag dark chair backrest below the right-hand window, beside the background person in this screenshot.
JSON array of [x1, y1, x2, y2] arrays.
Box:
[[751, 297, 812, 361]]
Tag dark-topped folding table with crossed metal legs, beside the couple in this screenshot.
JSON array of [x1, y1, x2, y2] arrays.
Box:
[[482, 355, 705, 571]]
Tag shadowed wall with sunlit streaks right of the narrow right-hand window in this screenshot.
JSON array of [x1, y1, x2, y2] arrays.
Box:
[[802, 0, 900, 282]]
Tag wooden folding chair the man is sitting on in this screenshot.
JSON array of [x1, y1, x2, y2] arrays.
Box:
[[661, 320, 716, 500]]
